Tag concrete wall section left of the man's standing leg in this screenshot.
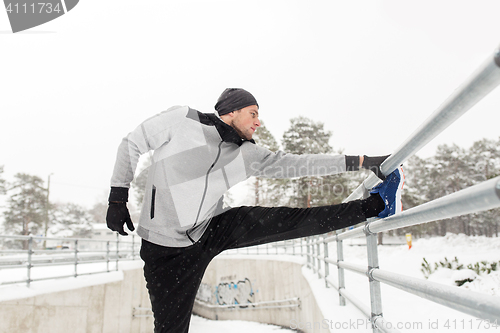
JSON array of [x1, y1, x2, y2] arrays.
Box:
[[0, 268, 153, 333]]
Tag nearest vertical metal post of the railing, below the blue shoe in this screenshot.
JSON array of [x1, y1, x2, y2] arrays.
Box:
[[366, 223, 383, 333]]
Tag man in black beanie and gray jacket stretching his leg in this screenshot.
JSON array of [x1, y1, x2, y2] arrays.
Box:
[[106, 88, 402, 332]]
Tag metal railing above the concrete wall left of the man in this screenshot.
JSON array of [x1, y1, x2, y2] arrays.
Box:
[[0, 234, 141, 287]]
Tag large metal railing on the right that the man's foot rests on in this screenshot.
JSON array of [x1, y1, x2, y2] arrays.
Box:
[[226, 44, 500, 332]]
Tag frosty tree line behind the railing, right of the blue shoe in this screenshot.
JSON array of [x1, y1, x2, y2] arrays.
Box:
[[397, 139, 500, 236]]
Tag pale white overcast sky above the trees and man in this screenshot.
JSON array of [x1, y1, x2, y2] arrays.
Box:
[[0, 0, 500, 207]]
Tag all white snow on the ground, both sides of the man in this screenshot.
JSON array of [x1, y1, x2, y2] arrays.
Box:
[[0, 234, 500, 333]]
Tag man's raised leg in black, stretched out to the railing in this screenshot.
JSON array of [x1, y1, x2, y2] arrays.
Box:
[[210, 195, 385, 252]]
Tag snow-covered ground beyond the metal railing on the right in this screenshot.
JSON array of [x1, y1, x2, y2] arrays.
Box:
[[316, 234, 500, 332]]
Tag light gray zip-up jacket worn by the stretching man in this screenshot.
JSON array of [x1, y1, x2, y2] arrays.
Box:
[[111, 106, 346, 247]]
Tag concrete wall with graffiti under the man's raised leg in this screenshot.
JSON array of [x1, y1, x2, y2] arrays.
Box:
[[194, 256, 330, 332]]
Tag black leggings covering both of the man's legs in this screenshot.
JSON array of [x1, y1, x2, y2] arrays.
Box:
[[141, 200, 366, 333]]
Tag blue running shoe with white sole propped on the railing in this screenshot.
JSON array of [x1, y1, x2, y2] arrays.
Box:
[[370, 166, 405, 218]]
